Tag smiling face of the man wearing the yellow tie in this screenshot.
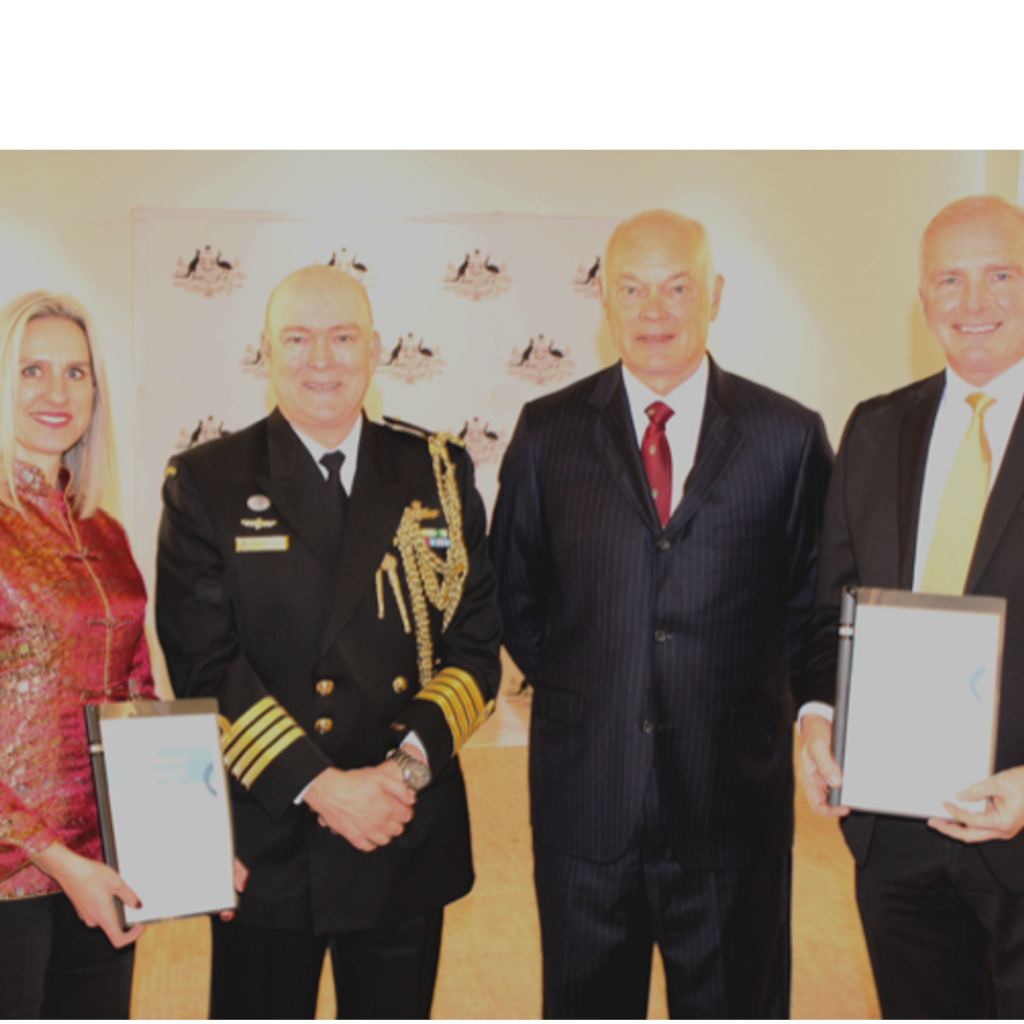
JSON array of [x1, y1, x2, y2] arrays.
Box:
[[919, 200, 1024, 387]]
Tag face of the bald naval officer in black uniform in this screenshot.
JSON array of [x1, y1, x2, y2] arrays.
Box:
[[262, 266, 380, 449]]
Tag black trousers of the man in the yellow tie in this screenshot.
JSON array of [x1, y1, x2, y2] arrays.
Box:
[[857, 817, 1024, 1020]]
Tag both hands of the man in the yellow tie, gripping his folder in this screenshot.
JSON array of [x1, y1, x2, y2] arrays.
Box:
[[800, 715, 1024, 843]]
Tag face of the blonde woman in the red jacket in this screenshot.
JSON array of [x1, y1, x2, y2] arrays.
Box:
[[15, 316, 95, 485]]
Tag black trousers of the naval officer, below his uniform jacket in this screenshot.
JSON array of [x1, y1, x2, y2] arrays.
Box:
[[210, 908, 444, 1020]]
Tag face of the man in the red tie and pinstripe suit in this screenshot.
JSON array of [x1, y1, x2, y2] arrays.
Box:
[[601, 210, 724, 395]]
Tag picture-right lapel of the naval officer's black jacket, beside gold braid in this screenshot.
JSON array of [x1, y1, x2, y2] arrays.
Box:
[[321, 420, 413, 656]]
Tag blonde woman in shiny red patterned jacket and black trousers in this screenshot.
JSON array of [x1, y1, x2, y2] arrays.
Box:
[[0, 292, 153, 1019]]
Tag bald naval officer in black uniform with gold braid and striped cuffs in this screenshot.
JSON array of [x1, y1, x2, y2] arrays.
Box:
[[157, 266, 501, 1019]]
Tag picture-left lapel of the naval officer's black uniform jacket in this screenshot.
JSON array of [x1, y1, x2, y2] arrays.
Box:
[[256, 410, 331, 565]]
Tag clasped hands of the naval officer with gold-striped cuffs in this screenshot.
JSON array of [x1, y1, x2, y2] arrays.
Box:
[[303, 748, 422, 853]]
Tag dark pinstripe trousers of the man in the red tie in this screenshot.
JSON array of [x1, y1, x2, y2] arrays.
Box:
[[534, 774, 792, 1020]]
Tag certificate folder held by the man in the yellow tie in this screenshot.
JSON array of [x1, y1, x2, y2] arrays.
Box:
[[829, 587, 1007, 817]]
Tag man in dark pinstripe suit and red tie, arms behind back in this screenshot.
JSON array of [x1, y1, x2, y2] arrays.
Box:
[[492, 210, 831, 1018]]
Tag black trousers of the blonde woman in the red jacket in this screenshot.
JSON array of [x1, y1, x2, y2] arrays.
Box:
[[0, 893, 135, 1020]]
